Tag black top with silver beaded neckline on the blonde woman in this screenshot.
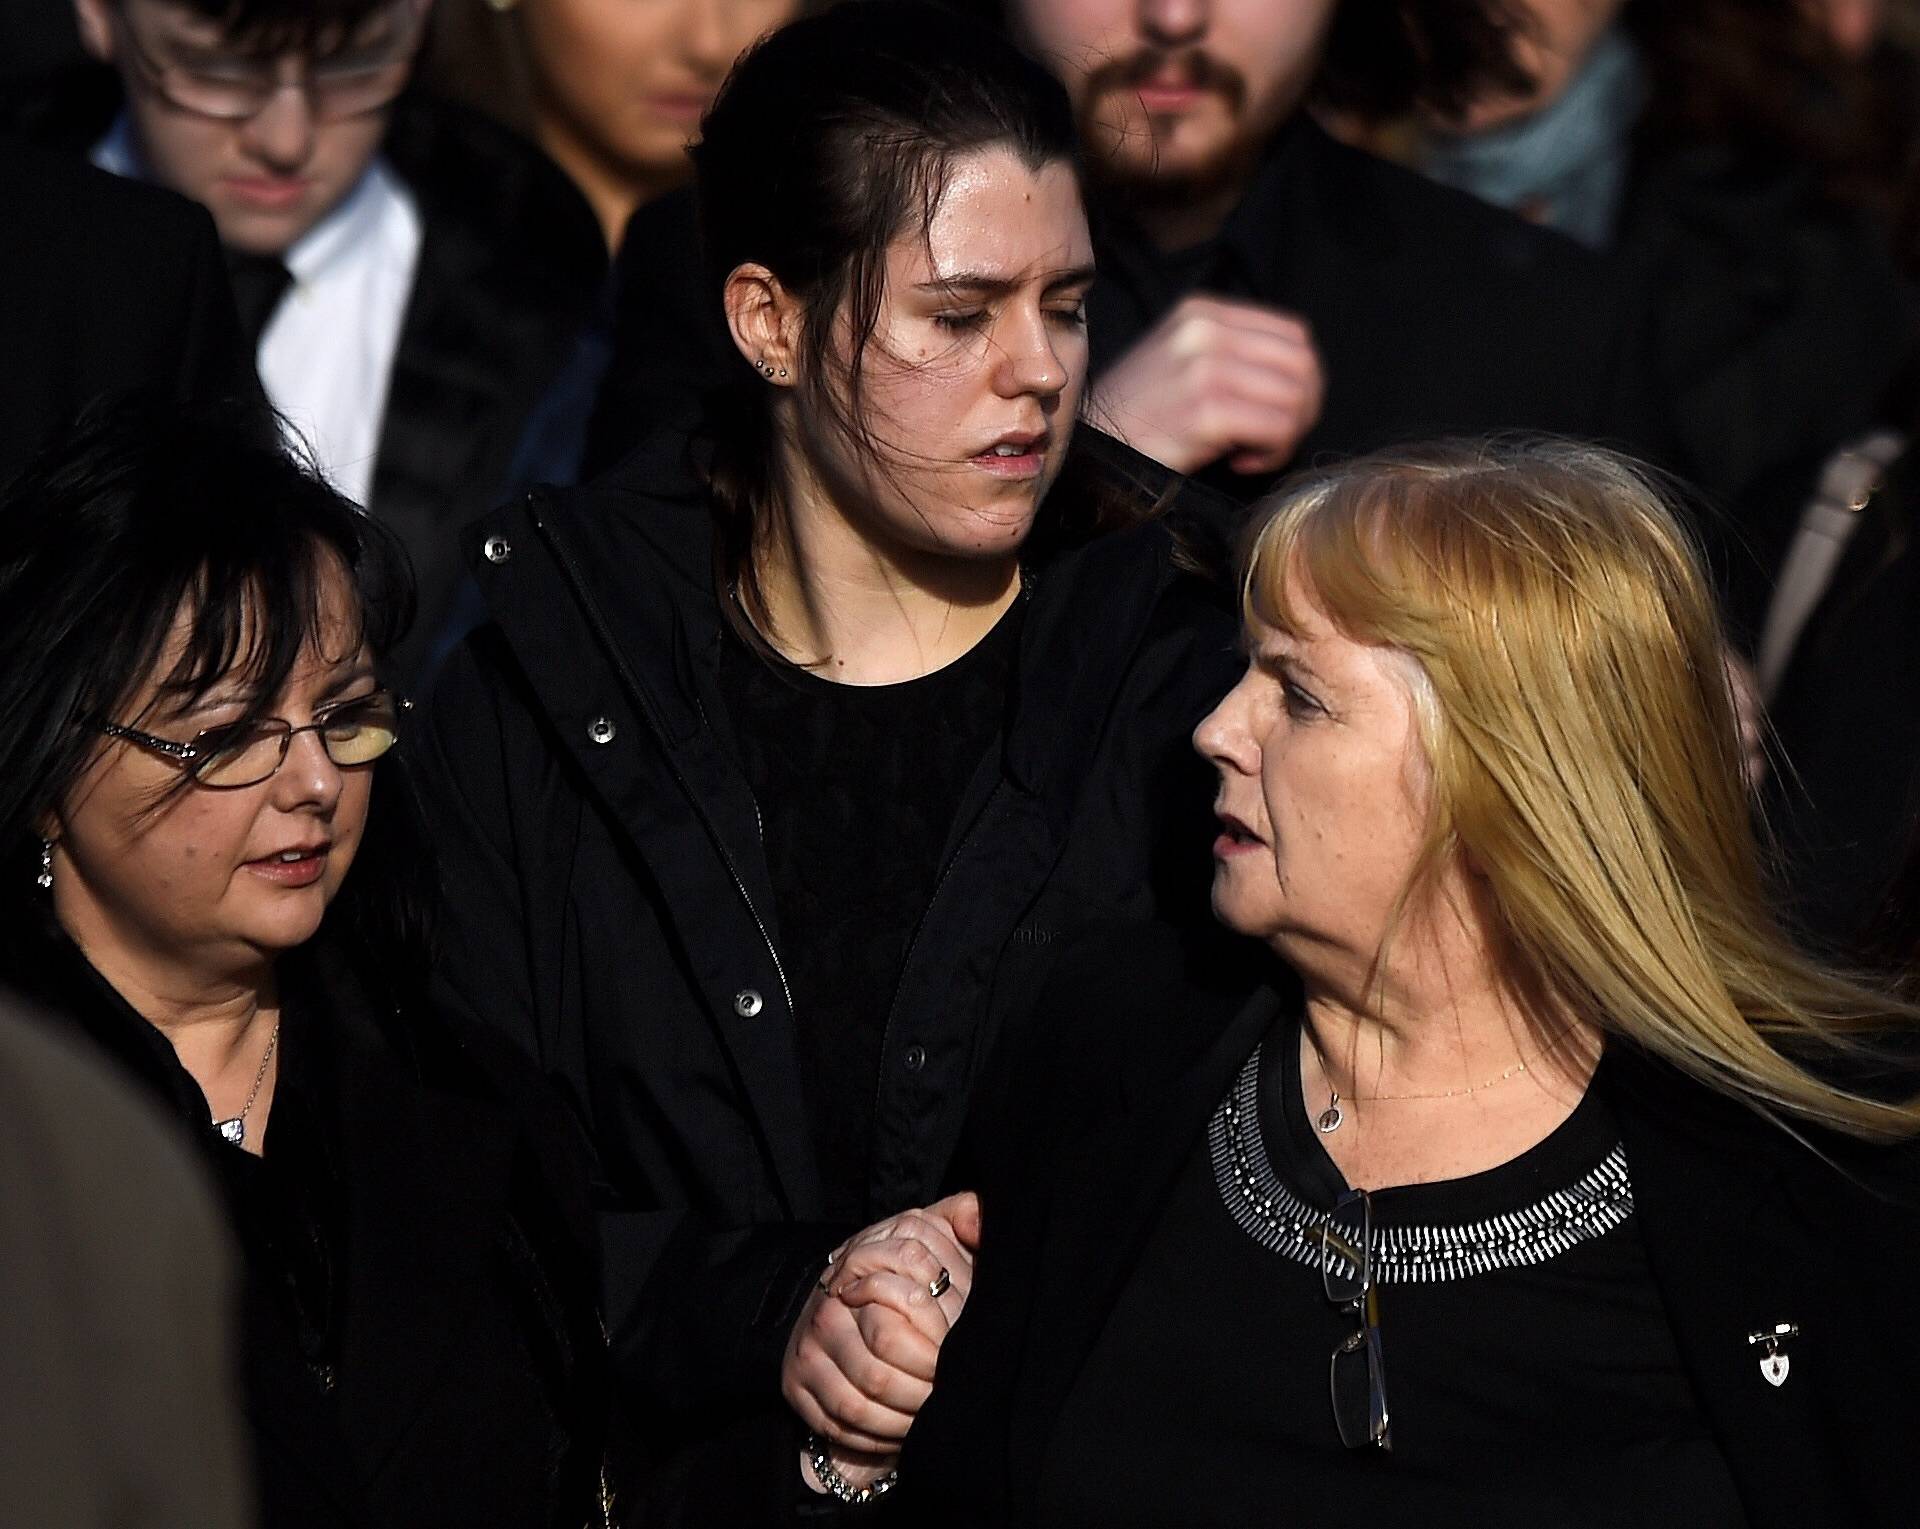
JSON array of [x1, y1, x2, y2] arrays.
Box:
[[1039, 1016, 1745, 1529]]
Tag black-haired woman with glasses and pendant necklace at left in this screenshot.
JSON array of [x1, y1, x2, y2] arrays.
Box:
[[0, 403, 605, 1529]]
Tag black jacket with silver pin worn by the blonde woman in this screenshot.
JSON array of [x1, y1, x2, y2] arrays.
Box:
[[891, 941, 1920, 1529]]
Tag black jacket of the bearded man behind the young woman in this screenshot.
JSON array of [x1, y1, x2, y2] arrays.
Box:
[[588, 115, 1667, 489]]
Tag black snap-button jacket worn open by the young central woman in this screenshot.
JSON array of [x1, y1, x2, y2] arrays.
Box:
[[412, 418, 1238, 1523]]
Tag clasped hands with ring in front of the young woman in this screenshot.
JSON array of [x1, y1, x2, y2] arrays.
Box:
[[780, 1195, 979, 1485]]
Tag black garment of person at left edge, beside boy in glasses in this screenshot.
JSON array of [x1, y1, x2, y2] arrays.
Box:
[[0, 142, 259, 486]]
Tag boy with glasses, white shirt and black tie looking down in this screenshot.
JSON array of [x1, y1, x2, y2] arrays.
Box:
[[73, 0, 603, 670]]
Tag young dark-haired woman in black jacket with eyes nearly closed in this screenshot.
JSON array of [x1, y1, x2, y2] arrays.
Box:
[[414, 4, 1233, 1523]]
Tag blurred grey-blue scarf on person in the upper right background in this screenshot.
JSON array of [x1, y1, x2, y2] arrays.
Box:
[[1421, 29, 1647, 250]]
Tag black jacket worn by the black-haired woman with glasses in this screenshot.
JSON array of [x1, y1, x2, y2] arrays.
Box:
[[0, 920, 607, 1529]]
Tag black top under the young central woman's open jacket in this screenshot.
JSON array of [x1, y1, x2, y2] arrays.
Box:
[[720, 599, 1023, 1222]]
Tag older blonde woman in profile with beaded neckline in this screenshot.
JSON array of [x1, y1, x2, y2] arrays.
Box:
[[890, 444, 1920, 1529]]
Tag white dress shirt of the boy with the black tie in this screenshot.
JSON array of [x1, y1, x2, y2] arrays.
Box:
[[92, 117, 424, 505]]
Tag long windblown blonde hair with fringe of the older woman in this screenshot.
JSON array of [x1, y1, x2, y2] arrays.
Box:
[[1240, 440, 1920, 1139]]
